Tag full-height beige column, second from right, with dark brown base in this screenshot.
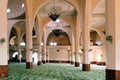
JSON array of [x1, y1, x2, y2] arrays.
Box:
[[81, 0, 92, 71]]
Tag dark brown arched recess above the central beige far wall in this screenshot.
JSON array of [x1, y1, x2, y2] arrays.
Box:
[[47, 29, 70, 46]]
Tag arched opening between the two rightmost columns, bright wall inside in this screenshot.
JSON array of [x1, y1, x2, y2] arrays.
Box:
[[90, 30, 106, 65]]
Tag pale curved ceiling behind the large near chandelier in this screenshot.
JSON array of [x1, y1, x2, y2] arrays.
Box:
[[39, 0, 76, 17]]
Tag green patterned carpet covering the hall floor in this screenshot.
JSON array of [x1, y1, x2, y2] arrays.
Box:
[[0, 63, 105, 80]]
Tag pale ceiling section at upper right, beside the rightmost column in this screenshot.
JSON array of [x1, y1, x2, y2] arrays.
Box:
[[91, 0, 106, 27]]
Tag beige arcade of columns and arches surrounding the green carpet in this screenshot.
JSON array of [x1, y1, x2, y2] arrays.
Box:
[[0, 0, 120, 80]]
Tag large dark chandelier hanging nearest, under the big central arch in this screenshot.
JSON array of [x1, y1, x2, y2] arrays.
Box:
[[48, 0, 60, 21]]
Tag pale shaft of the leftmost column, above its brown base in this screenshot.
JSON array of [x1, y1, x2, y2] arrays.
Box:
[[0, 0, 8, 65]]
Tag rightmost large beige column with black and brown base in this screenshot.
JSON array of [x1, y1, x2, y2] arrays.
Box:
[[106, 0, 120, 80]]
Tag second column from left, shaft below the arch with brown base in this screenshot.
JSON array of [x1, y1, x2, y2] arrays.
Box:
[[26, 18, 33, 69]]
